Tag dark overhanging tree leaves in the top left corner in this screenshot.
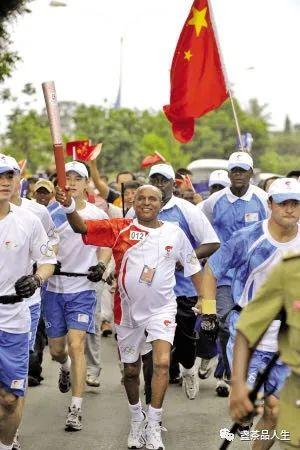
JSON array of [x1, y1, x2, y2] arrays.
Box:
[[0, 0, 30, 83]]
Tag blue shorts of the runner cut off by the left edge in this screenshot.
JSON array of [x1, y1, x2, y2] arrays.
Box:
[[0, 331, 29, 397]]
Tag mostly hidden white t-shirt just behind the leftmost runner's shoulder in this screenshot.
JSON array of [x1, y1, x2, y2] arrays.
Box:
[[20, 198, 59, 306]]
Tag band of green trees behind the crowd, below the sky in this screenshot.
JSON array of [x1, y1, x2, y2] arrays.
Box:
[[0, 94, 300, 174]]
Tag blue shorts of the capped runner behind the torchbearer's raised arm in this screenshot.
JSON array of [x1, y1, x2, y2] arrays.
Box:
[[42, 291, 96, 338]]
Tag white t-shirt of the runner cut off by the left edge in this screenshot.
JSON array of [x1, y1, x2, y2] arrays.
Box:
[[0, 204, 56, 333]]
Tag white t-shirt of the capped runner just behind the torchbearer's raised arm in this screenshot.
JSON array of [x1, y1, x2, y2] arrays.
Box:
[[47, 202, 108, 294]]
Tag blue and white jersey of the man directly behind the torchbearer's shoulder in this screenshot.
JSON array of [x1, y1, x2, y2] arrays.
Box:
[[158, 196, 220, 297]]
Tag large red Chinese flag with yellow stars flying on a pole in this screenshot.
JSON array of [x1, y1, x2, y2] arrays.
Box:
[[164, 0, 228, 142]]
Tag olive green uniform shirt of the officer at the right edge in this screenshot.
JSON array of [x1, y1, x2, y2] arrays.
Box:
[[237, 254, 300, 375]]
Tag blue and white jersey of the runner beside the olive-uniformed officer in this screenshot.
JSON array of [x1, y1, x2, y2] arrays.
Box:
[[208, 220, 300, 352]]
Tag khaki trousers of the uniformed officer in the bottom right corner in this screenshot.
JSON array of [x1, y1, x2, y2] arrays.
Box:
[[276, 373, 300, 450]]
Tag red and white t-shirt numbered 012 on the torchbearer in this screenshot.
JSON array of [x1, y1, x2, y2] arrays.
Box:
[[83, 219, 201, 328]]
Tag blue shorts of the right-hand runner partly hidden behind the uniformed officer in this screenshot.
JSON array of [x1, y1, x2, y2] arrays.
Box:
[[227, 311, 290, 398]]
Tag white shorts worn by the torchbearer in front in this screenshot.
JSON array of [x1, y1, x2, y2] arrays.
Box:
[[116, 313, 176, 364]]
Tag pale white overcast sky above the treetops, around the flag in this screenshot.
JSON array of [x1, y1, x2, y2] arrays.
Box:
[[0, 0, 300, 130]]
